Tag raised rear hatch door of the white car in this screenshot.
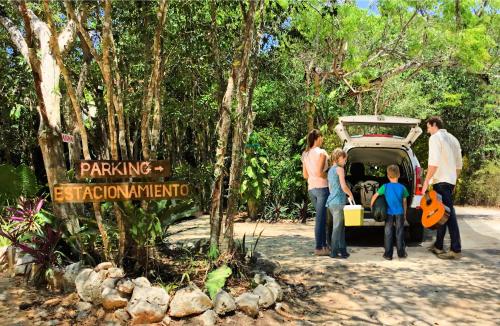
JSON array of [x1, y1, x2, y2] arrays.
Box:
[[335, 115, 422, 148]]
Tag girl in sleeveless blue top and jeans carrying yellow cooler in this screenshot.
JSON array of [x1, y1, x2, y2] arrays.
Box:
[[326, 148, 353, 258]]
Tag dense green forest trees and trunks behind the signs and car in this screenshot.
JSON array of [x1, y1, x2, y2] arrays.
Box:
[[0, 0, 500, 262]]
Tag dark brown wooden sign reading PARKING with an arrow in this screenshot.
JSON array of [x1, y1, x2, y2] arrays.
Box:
[[76, 161, 171, 179]]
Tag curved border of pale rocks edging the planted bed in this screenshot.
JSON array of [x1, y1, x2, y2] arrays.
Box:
[[0, 253, 283, 326]]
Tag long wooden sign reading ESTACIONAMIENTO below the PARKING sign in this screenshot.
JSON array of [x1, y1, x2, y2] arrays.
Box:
[[53, 181, 189, 203]]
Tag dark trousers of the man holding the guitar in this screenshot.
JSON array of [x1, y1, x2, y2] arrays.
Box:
[[432, 182, 462, 252]]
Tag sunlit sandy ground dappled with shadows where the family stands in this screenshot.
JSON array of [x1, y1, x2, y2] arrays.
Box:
[[171, 207, 500, 325]]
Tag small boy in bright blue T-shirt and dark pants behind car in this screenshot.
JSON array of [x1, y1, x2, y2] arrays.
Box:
[[371, 165, 409, 260]]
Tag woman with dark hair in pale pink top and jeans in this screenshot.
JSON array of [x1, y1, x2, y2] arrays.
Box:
[[301, 129, 329, 256]]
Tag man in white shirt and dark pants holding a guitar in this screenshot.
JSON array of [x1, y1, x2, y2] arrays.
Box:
[[422, 117, 462, 259]]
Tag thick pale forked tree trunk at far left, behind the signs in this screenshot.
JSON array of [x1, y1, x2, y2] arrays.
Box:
[[0, 1, 80, 234]]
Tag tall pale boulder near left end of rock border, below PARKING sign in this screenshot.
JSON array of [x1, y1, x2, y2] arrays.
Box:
[[75, 268, 107, 304]]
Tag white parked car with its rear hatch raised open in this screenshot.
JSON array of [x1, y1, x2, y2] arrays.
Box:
[[335, 115, 423, 241]]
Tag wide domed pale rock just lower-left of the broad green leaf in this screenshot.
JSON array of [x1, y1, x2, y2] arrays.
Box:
[[169, 285, 213, 317]]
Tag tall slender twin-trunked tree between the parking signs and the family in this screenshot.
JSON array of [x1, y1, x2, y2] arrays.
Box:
[[210, 0, 263, 251]]
